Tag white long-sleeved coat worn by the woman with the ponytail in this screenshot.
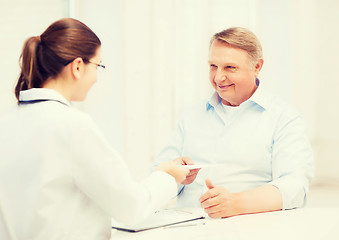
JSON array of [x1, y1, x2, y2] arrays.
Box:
[[0, 89, 177, 240]]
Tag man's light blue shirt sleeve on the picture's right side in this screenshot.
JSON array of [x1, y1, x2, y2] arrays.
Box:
[[270, 111, 314, 209]]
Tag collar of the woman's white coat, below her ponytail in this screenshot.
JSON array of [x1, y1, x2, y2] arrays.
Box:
[[19, 88, 70, 106]]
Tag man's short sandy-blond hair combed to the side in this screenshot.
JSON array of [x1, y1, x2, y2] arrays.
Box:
[[210, 27, 263, 65]]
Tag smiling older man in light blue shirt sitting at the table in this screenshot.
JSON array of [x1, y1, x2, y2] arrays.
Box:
[[155, 28, 313, 218]]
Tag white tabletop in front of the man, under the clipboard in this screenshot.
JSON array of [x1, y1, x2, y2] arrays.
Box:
[[111, 208, 339, 240]]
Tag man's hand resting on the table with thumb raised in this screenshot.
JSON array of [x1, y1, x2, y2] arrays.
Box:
[[199, 179, 239, 218]]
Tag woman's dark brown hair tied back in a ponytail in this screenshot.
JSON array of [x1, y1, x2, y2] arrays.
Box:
[[15, 18, 101, 101]]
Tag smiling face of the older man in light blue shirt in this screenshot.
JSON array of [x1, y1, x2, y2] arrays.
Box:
[[208, 40, 263, 106]]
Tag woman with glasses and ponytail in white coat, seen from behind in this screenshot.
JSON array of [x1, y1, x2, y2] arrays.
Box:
[[0, 19, 189, 240]]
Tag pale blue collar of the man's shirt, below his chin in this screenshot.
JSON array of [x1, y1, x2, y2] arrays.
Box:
[[206, 82, 271, 111]]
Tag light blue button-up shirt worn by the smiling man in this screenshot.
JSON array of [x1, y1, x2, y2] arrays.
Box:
[[155, 84, 313, 209]]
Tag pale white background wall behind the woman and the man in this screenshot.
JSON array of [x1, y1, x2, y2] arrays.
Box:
[[0, 0, 339, 183]]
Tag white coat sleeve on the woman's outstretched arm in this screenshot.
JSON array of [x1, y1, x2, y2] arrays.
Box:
[[68, 114, 177, 224]]
